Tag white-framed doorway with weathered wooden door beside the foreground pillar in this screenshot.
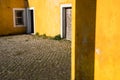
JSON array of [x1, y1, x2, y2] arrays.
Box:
[[61, 4, 72, 41]]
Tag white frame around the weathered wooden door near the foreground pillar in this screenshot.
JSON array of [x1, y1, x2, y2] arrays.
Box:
[[60, 4, 72, 38]]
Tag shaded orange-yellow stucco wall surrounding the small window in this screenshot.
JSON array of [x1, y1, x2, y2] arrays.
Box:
[[0, 0, 25, 35]]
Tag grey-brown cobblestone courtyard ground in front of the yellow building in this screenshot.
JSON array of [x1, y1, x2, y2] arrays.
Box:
[[0, 35, 71, 80]]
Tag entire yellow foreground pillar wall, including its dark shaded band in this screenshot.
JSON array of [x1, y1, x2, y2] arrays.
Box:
[[71, 0, 120, 80]]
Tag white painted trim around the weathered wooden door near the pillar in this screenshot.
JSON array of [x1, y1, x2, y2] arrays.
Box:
[[60, 4, 72, 38]]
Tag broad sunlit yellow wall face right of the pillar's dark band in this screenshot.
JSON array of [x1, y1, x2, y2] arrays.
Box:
[[95, 0, 120, 80]]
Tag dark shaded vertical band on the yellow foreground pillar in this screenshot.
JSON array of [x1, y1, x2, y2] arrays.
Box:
[[75, 0, 96, 80]]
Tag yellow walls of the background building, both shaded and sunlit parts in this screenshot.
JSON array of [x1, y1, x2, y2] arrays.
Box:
[[0, 0, 72, 36]]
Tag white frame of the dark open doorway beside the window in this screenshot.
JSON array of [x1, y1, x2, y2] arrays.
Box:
[[27, 7, 36, 34]]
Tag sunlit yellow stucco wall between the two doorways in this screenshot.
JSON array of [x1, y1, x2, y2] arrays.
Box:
[[28, 0, 72, 36]]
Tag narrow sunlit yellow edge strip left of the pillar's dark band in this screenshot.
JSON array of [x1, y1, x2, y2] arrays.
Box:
[[71, 0, 77, 80]]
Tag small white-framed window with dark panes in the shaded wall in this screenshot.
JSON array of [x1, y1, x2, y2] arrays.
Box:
[[13, 8, 26, 27]]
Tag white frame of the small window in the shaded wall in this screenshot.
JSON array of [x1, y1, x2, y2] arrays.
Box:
[[13, 8, 26, 27]]
